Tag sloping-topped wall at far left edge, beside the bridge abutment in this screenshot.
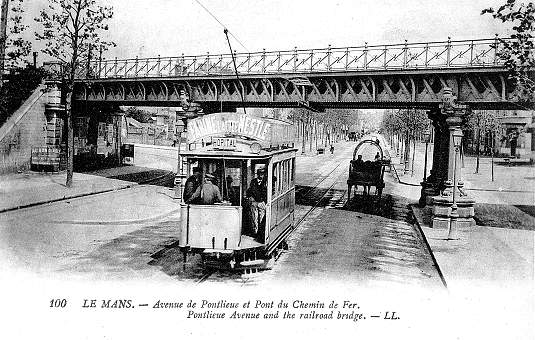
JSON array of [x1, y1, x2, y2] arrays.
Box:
[[0, 86, 47, 174]]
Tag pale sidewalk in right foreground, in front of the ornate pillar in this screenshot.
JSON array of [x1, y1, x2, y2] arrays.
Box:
[[412, 206, 535, 290]]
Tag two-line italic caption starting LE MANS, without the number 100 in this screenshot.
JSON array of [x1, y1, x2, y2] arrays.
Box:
[[76, 299, 400, 322]]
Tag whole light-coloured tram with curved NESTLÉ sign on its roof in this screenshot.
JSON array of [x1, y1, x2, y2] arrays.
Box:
[[179, 113, 297, 268]]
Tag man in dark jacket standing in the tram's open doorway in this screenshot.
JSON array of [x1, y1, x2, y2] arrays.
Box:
[[246, 168, 267, 235]]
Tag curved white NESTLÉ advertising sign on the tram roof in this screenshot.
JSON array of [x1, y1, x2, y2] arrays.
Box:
[[188, 112, 294, 145]]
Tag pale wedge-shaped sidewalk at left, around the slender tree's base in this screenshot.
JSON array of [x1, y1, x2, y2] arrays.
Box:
[[0, 172, 136, 213]]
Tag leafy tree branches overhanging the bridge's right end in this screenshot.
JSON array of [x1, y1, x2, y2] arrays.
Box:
[[481, 0, 535, 107]]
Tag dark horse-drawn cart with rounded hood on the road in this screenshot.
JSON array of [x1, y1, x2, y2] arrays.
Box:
[[347, 139, 390, 199]]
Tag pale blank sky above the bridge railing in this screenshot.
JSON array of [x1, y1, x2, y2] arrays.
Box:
[[26, 0, 509, 58]]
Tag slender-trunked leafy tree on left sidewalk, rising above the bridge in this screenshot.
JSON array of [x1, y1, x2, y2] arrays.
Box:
[[35, 0, 115, 187]]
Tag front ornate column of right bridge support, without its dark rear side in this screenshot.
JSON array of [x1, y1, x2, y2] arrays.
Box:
[[432, 88, 475, 229]]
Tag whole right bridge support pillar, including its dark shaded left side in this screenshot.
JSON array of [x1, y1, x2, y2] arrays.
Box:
[[428, 88, 475, 229]]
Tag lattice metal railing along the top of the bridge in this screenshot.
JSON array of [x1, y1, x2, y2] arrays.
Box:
[[78, 38, 510, 79]]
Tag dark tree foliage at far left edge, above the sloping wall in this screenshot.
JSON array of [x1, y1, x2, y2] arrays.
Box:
[[0, 0, 32, 76]]
